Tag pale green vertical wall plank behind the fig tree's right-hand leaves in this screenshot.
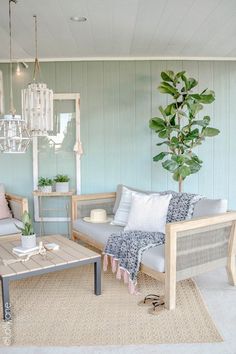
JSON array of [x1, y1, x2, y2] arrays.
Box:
[[198, 61, 215, 198]]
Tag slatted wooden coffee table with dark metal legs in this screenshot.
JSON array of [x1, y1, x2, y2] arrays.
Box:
[[0, 235, 101, 320]]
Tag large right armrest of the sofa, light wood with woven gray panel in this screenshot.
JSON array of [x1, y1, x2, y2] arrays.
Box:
[[165, 211, 236, 309]]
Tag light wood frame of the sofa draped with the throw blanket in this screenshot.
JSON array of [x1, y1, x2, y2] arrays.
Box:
[[72, 193, 236, 310]]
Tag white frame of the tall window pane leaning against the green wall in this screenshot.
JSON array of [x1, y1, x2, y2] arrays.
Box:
[[32, 93, 81, 222]]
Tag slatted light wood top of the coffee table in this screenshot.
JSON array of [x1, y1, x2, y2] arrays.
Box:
[[0, 235, 100, 277]]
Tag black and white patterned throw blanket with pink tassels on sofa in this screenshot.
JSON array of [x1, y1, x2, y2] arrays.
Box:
[[103, 191, 203, 294]]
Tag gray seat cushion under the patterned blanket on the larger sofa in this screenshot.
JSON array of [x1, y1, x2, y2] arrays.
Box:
[[73, 219, 165, 272]]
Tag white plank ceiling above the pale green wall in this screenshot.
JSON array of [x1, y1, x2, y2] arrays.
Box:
[[0, 0, 236, 61]]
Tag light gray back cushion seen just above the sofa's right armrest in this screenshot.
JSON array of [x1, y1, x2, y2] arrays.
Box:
[[192, 199, 228, 218]]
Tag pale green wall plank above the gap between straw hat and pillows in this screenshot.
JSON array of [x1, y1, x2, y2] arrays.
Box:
[[103, 61, 122, 191]]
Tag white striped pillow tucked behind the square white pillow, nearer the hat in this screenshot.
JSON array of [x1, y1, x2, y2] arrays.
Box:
[[111, 186, 134, 226]]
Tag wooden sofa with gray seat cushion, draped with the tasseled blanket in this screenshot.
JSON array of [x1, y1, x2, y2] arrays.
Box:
[[72, 188, 236, 310]]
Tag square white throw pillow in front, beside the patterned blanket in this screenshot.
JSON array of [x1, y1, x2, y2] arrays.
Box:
[[124, 192, 172, 233]]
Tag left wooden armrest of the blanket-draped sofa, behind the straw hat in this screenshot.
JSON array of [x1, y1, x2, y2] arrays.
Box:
[[72, 192, 116, 220]]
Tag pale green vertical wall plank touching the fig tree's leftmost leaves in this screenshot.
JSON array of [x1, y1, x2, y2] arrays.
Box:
[[134, 61, 152, 190]]
